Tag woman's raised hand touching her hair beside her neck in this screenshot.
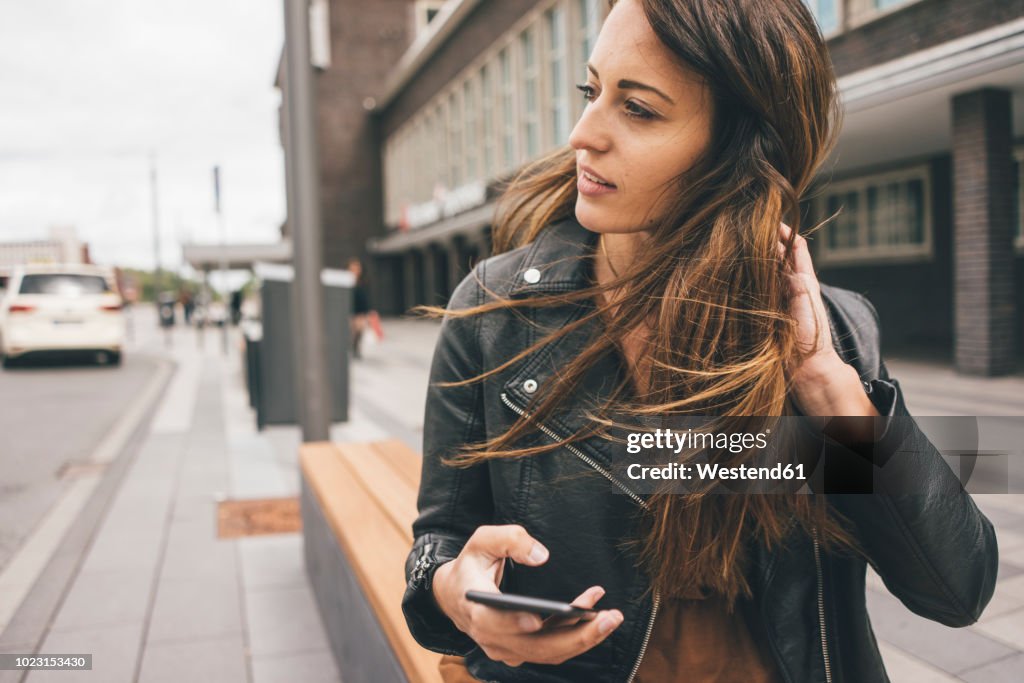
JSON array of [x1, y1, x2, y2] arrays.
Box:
[[778, 223, 878, 416]]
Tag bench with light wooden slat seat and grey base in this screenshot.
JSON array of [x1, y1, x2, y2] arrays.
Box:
[[299, 439, 441, 683]]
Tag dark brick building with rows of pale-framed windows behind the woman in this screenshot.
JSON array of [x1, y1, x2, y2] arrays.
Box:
[[284, 0, 1024, 375]]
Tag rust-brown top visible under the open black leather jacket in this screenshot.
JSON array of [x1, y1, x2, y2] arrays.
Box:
[[439, 596, 782, 683]]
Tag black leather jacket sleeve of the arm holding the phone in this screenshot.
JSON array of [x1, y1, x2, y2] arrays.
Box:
[[401, 263, 493, 656]]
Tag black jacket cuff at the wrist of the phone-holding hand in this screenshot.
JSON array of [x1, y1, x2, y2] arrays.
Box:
[[401, 533, 477, 656]]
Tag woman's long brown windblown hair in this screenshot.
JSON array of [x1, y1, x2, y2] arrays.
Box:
[[419, 0, 856, 606]]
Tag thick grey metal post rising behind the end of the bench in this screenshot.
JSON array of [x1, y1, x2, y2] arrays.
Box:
[[285, 0, 332, 441]]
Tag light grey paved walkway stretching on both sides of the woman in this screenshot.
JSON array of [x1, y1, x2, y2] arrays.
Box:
[[0, 311, 1024, 683]]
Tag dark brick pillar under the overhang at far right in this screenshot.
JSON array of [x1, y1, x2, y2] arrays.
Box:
[[952, 88, 1017, 376]]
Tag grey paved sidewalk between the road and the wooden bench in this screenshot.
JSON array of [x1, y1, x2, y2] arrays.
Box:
[[0, 311, 405, 683]]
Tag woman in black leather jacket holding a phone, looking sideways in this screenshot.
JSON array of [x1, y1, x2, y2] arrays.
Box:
[[402, 0, 997, 683]]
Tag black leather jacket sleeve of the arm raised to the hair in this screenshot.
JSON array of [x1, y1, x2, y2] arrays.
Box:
[[828, 297, 998, 627]]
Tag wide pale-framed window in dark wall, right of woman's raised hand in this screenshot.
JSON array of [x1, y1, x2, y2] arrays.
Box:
[[821, 167, 932, 261]]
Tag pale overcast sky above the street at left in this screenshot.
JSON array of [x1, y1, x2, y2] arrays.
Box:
[[0, 0, 285, 268]]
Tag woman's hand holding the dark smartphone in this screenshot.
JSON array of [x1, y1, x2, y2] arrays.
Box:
[[433, 524, 623, 667]]
